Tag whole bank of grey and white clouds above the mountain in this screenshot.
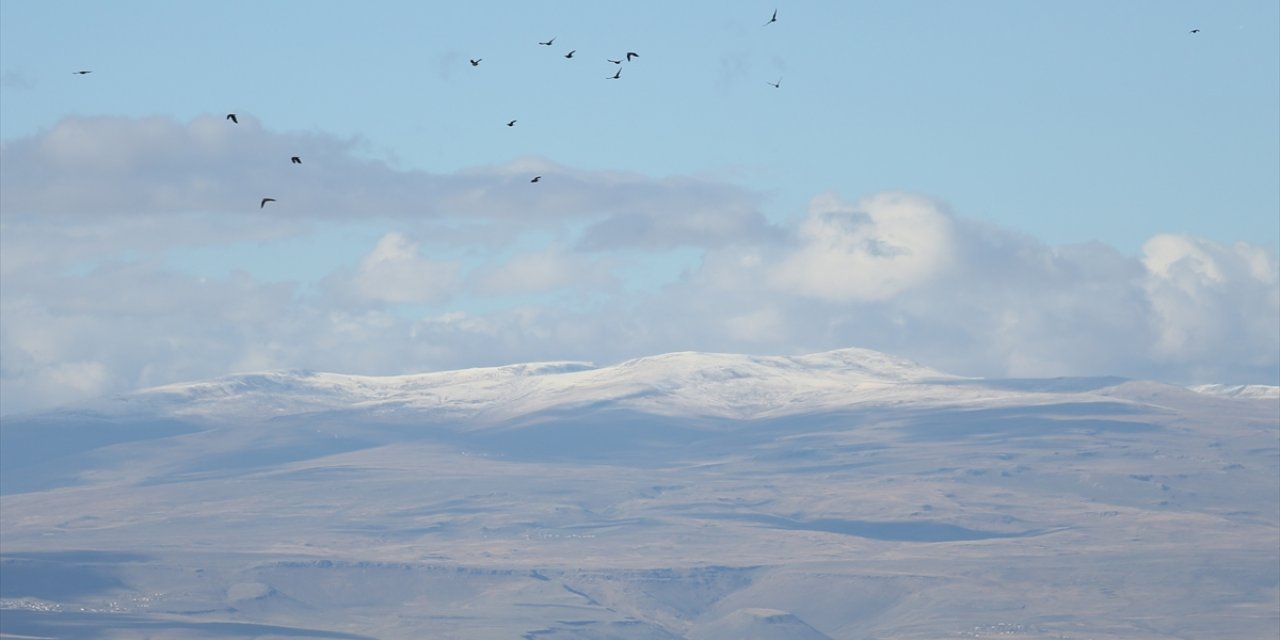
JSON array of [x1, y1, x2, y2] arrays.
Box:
[[0, 115, 1280, 415]]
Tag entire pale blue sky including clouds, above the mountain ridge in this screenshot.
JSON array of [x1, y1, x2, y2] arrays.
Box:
[[0, 0, 1280, 415]]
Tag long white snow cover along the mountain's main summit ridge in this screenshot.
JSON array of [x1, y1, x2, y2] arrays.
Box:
[[97, 348, 1111, 421]]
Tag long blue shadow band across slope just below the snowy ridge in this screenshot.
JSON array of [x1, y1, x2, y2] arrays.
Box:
[[0, 391, 1158, 494]]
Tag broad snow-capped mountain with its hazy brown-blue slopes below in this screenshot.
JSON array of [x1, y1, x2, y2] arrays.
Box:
[[0, 348, 1280, 639]]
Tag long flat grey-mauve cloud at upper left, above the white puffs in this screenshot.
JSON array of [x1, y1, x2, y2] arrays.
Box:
[[0, 114, 771, 248]]
